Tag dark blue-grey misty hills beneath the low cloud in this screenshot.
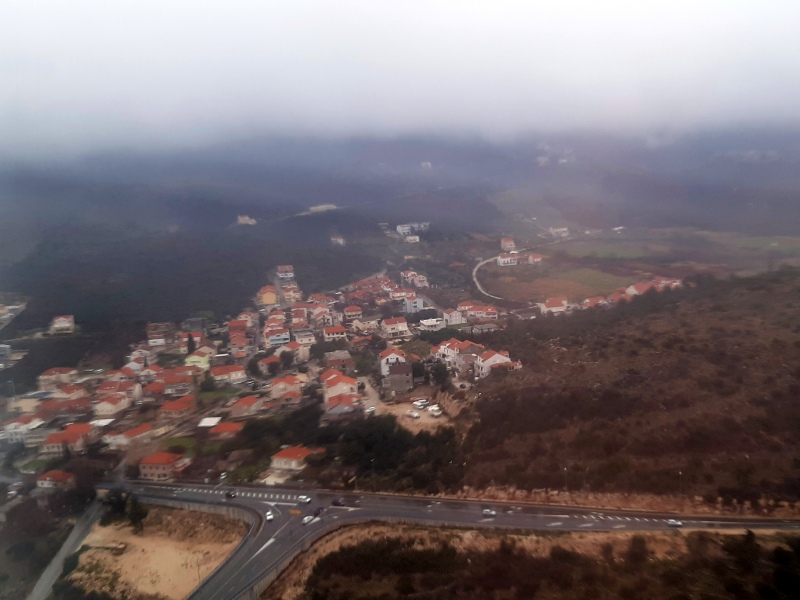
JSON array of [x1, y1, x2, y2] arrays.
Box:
[[0, 130, 800, 326]]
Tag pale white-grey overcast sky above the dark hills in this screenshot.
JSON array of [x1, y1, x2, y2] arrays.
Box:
[[0, 0, 800, 154]]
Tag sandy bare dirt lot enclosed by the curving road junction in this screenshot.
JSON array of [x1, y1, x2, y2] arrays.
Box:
[[70, 507, 246, 600]]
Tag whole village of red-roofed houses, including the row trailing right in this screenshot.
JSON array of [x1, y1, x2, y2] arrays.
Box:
[[0, 230, 681, 516]]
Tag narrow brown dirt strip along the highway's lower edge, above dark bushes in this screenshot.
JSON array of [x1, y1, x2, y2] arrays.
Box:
[[261, 523, 780, 600]]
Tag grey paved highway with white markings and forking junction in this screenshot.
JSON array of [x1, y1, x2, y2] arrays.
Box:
[[120, 483, 800, 600]]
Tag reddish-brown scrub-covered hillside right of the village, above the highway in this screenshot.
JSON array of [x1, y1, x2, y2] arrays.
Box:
[[465, 269, 800, 500]]
